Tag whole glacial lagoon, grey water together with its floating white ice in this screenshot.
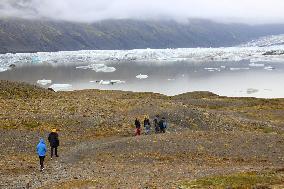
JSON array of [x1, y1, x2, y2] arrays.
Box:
[[0, 47, 284, 98]]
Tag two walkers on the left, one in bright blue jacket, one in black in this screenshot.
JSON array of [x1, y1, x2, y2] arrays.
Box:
[[36, 129, 59, 171]]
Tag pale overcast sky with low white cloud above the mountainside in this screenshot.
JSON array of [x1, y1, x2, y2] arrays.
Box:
[[0, 0, 284, 24]]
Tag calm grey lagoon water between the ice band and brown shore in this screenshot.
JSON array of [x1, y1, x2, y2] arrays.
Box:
[[0, 61, 284, 98]]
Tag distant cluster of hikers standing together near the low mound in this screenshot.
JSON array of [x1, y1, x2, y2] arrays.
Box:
[[134, 115, 168, 136]]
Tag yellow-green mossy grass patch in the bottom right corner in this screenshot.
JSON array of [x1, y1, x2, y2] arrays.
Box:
[[179, 171, 284, 189]]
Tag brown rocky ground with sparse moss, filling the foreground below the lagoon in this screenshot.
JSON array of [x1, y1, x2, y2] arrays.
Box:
[[0, 81, 284, 188]]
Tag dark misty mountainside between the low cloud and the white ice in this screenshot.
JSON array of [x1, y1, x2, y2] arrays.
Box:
[[0, 18, 284, 53]]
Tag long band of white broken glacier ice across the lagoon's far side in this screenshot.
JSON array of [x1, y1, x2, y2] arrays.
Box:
[[0, 45, 284, 72]]
